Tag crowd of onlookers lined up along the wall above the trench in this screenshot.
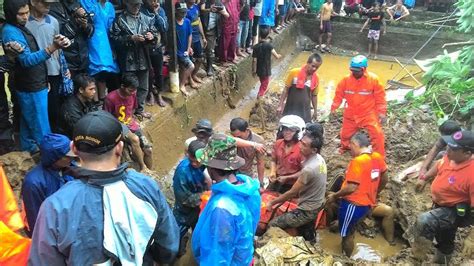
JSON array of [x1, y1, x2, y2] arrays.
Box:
[[0, 0, 409, 156]]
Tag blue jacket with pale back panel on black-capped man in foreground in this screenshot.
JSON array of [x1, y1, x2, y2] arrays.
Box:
[[28, 164, 179, 266]]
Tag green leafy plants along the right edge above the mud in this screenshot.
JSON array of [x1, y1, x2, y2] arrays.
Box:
[[390, 0, 474, 121]]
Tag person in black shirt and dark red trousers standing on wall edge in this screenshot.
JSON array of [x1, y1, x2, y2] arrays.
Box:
[[252, 28, 281, 99]]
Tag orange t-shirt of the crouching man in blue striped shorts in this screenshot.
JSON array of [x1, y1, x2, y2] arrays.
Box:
[[342, 152, 387, 206]]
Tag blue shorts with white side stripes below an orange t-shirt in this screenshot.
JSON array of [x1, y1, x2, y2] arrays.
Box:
[[338, 199, 370, 237]]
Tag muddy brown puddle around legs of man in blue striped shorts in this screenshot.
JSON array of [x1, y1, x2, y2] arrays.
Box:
[[318, 230, 402, 262]]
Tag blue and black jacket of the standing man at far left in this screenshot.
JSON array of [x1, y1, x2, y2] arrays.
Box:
[[2, 0, 50, 92]]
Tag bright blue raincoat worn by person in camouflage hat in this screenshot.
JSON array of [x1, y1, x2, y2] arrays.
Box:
[[192, 174, 262, 265]]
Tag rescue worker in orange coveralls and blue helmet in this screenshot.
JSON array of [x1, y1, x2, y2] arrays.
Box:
[[330, 55, 387, 156]]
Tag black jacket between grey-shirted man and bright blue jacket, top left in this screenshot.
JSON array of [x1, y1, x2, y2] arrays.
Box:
[[49, 0, 94, 72]]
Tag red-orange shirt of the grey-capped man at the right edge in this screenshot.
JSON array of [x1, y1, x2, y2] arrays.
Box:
[[431, 155, 474, 207]]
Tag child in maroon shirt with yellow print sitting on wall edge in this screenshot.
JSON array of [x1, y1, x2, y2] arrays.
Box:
[[104, 73, 153, 171]]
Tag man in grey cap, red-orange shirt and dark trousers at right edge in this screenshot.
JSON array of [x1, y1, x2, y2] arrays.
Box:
[[412, 130, 474, 264]]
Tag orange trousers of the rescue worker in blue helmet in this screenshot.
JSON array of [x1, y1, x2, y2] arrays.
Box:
[[341, 113, 385, 156]]
